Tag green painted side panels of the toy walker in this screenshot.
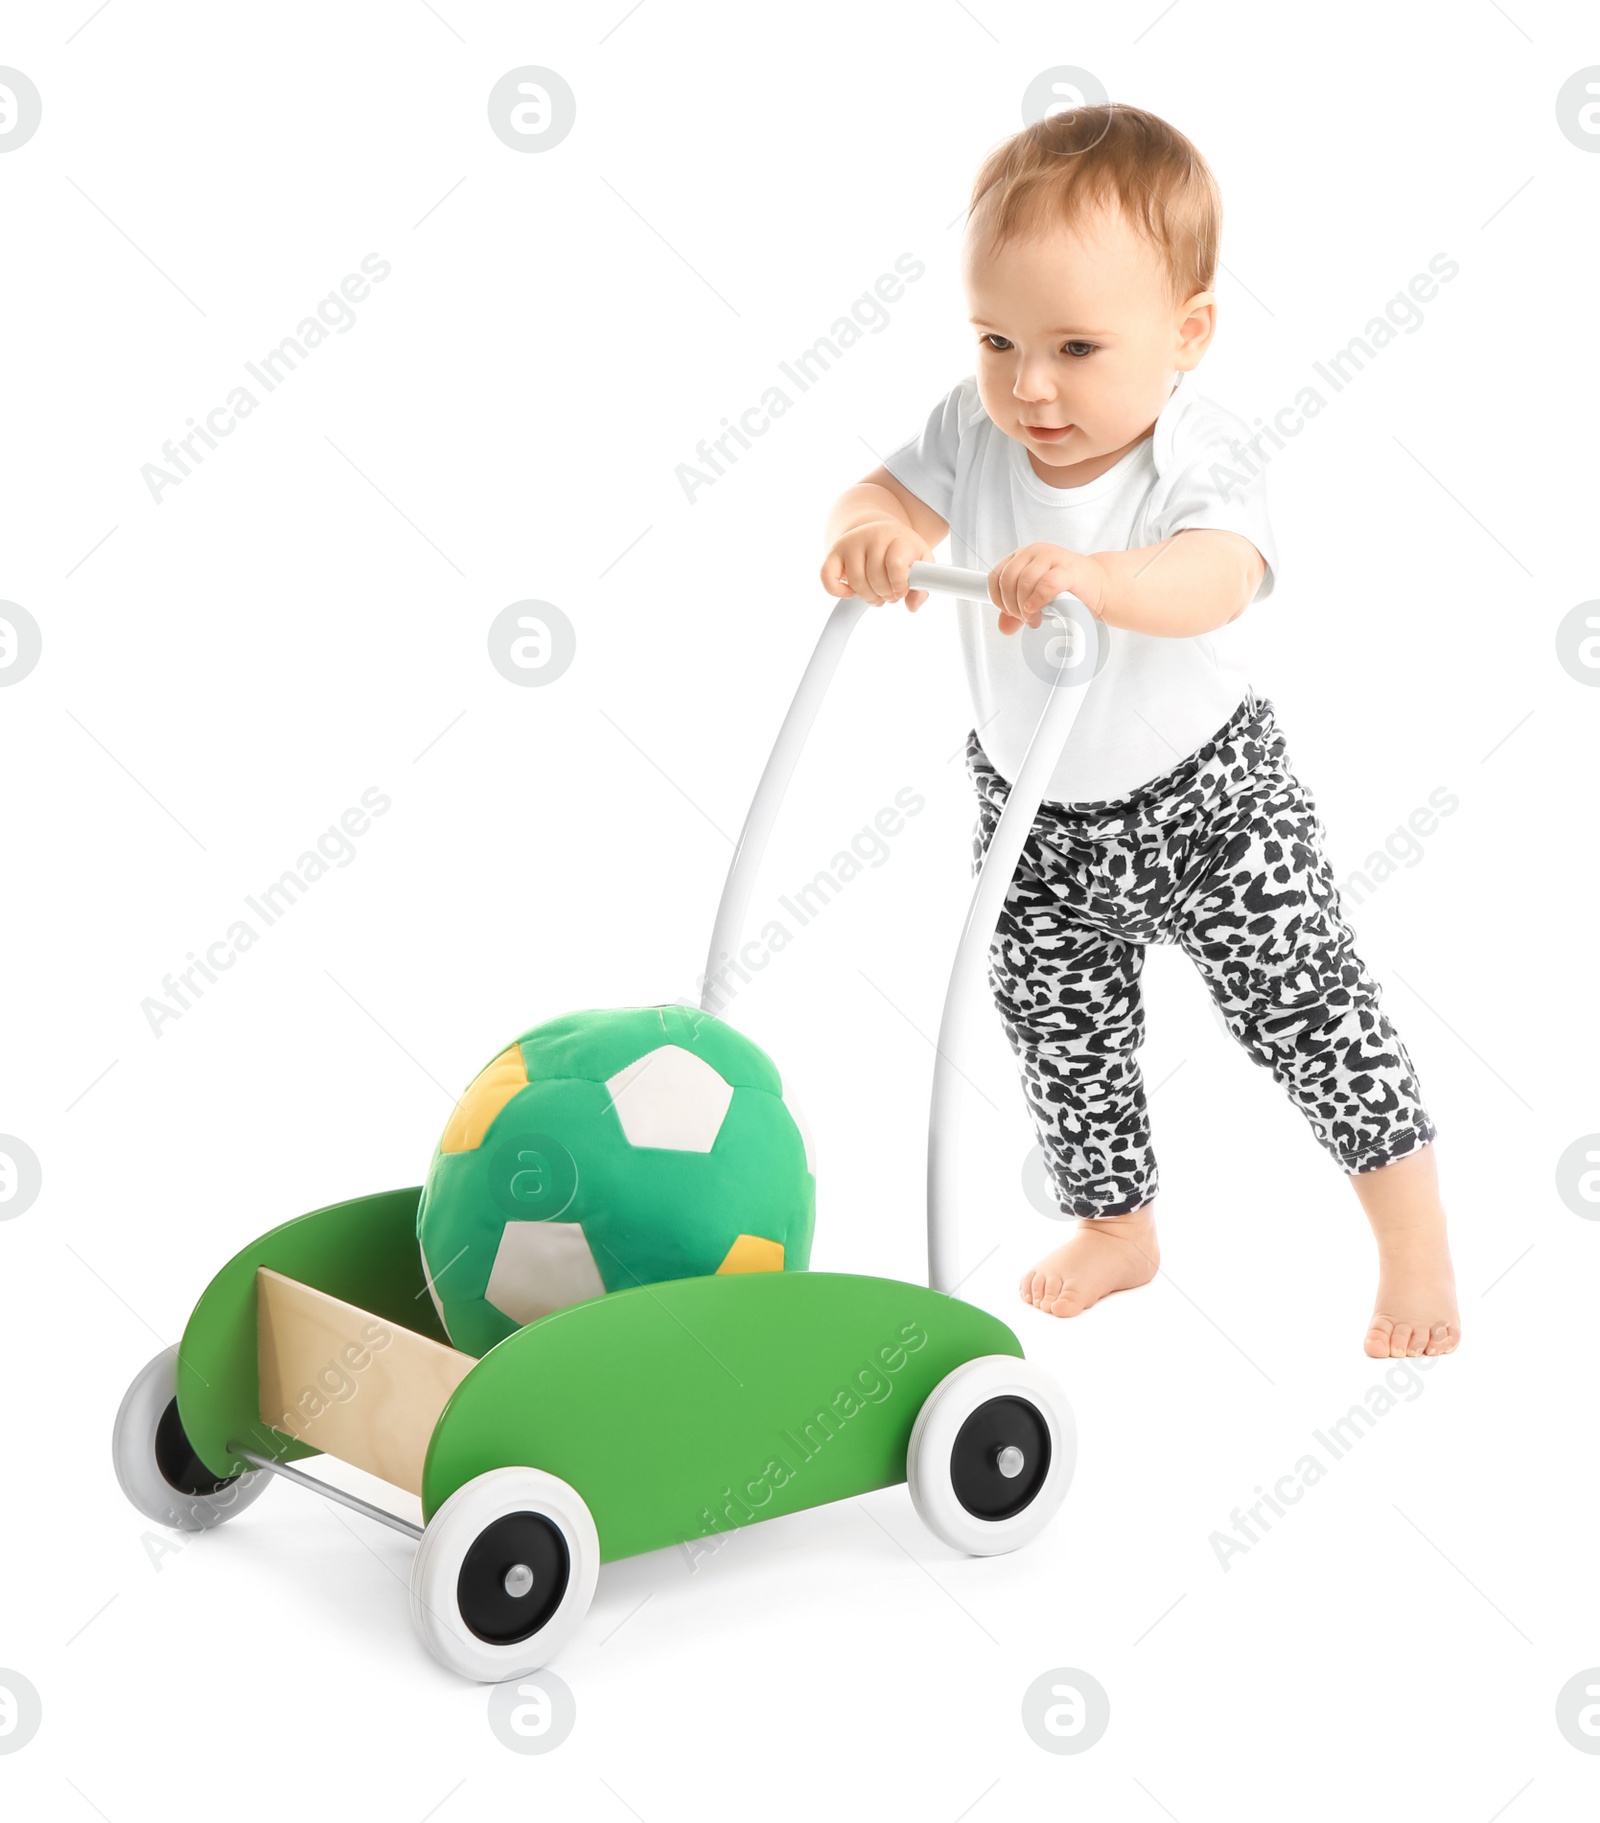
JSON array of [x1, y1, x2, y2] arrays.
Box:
[[177, 1189, 1022, 1560]]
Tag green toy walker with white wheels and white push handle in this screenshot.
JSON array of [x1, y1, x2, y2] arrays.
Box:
[[113, 563, 1099, 1681]]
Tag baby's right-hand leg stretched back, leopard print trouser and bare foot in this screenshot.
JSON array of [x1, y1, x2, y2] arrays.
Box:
[[1179, 738, 1462, 1358]]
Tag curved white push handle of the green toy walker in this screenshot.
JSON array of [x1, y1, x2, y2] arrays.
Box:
[[700, 563, 1101, 1293]]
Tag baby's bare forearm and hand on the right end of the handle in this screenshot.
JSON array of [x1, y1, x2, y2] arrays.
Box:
[[990, 525, 1267, 640]]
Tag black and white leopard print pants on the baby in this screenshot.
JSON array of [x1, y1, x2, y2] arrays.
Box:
[[966, 696, 1434, 1216]]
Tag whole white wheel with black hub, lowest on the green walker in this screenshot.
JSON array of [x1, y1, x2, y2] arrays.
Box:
[[412, 1468, 600, 1683]]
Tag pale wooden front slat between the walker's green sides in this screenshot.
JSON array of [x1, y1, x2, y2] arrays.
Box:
[[255, 1267, 477, 1495]]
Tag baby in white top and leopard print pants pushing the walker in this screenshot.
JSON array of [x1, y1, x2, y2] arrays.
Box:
[[822, 104, 1460, 1358]]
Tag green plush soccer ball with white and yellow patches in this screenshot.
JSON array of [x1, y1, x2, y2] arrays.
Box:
[[417, 1006, 816, 1354]]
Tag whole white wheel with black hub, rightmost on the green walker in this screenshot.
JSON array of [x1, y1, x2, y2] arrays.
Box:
[[906, 1354, 1077, 1557]]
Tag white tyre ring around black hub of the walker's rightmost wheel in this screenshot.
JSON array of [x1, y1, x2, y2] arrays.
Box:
[[906, 1354, 1077, 1557]]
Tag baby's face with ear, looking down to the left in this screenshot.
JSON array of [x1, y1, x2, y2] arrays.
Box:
[[962, 208, 1215, 487]]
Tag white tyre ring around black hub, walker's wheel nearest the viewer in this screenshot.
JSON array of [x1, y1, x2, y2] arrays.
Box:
[[412, 1468, 600, 1683]]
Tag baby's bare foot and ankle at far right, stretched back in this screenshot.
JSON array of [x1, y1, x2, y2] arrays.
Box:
[[1352, 1145, 1462, 1360]]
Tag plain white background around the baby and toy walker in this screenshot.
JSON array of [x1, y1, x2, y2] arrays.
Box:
[[0, 0, 1600, 1823]]
